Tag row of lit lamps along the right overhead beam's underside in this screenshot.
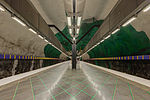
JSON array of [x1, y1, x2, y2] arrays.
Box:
[[80, 4, 150, 57]]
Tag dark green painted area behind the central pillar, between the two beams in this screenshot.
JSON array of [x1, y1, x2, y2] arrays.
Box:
[[56, 20, 103, 51]]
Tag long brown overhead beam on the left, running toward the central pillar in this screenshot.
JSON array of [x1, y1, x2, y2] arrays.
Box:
[[0, 0, 69, 56]]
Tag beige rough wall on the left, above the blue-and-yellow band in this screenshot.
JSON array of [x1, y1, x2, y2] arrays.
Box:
[[0, 12, 47, 56]]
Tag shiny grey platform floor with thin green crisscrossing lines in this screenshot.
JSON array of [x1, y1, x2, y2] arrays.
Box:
[[0, 62, 150, 100]]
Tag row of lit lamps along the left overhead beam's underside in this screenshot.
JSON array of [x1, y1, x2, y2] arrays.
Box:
[[0, 5, 68, 57]]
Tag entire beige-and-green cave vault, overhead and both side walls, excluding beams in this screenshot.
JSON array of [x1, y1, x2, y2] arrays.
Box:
[[0, 0, 150, 58]]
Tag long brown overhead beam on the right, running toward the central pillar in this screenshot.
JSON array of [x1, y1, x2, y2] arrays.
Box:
[[80, 0, 150, 56]]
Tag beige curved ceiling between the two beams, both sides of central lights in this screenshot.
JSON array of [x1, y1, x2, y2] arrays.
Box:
[[30, 0, 118, 33]]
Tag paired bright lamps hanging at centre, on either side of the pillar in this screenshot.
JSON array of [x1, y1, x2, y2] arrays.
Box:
[[67, 17, 82, 34]]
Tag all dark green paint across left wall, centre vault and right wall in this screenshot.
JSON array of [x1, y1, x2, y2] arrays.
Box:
[[44, 20, 150, 61]]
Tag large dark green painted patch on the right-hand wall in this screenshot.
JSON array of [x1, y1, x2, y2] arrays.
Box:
[[88, 25, 150, 58]]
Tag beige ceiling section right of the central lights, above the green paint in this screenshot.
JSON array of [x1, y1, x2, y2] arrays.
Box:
[[83, 0, 118, 20]]
